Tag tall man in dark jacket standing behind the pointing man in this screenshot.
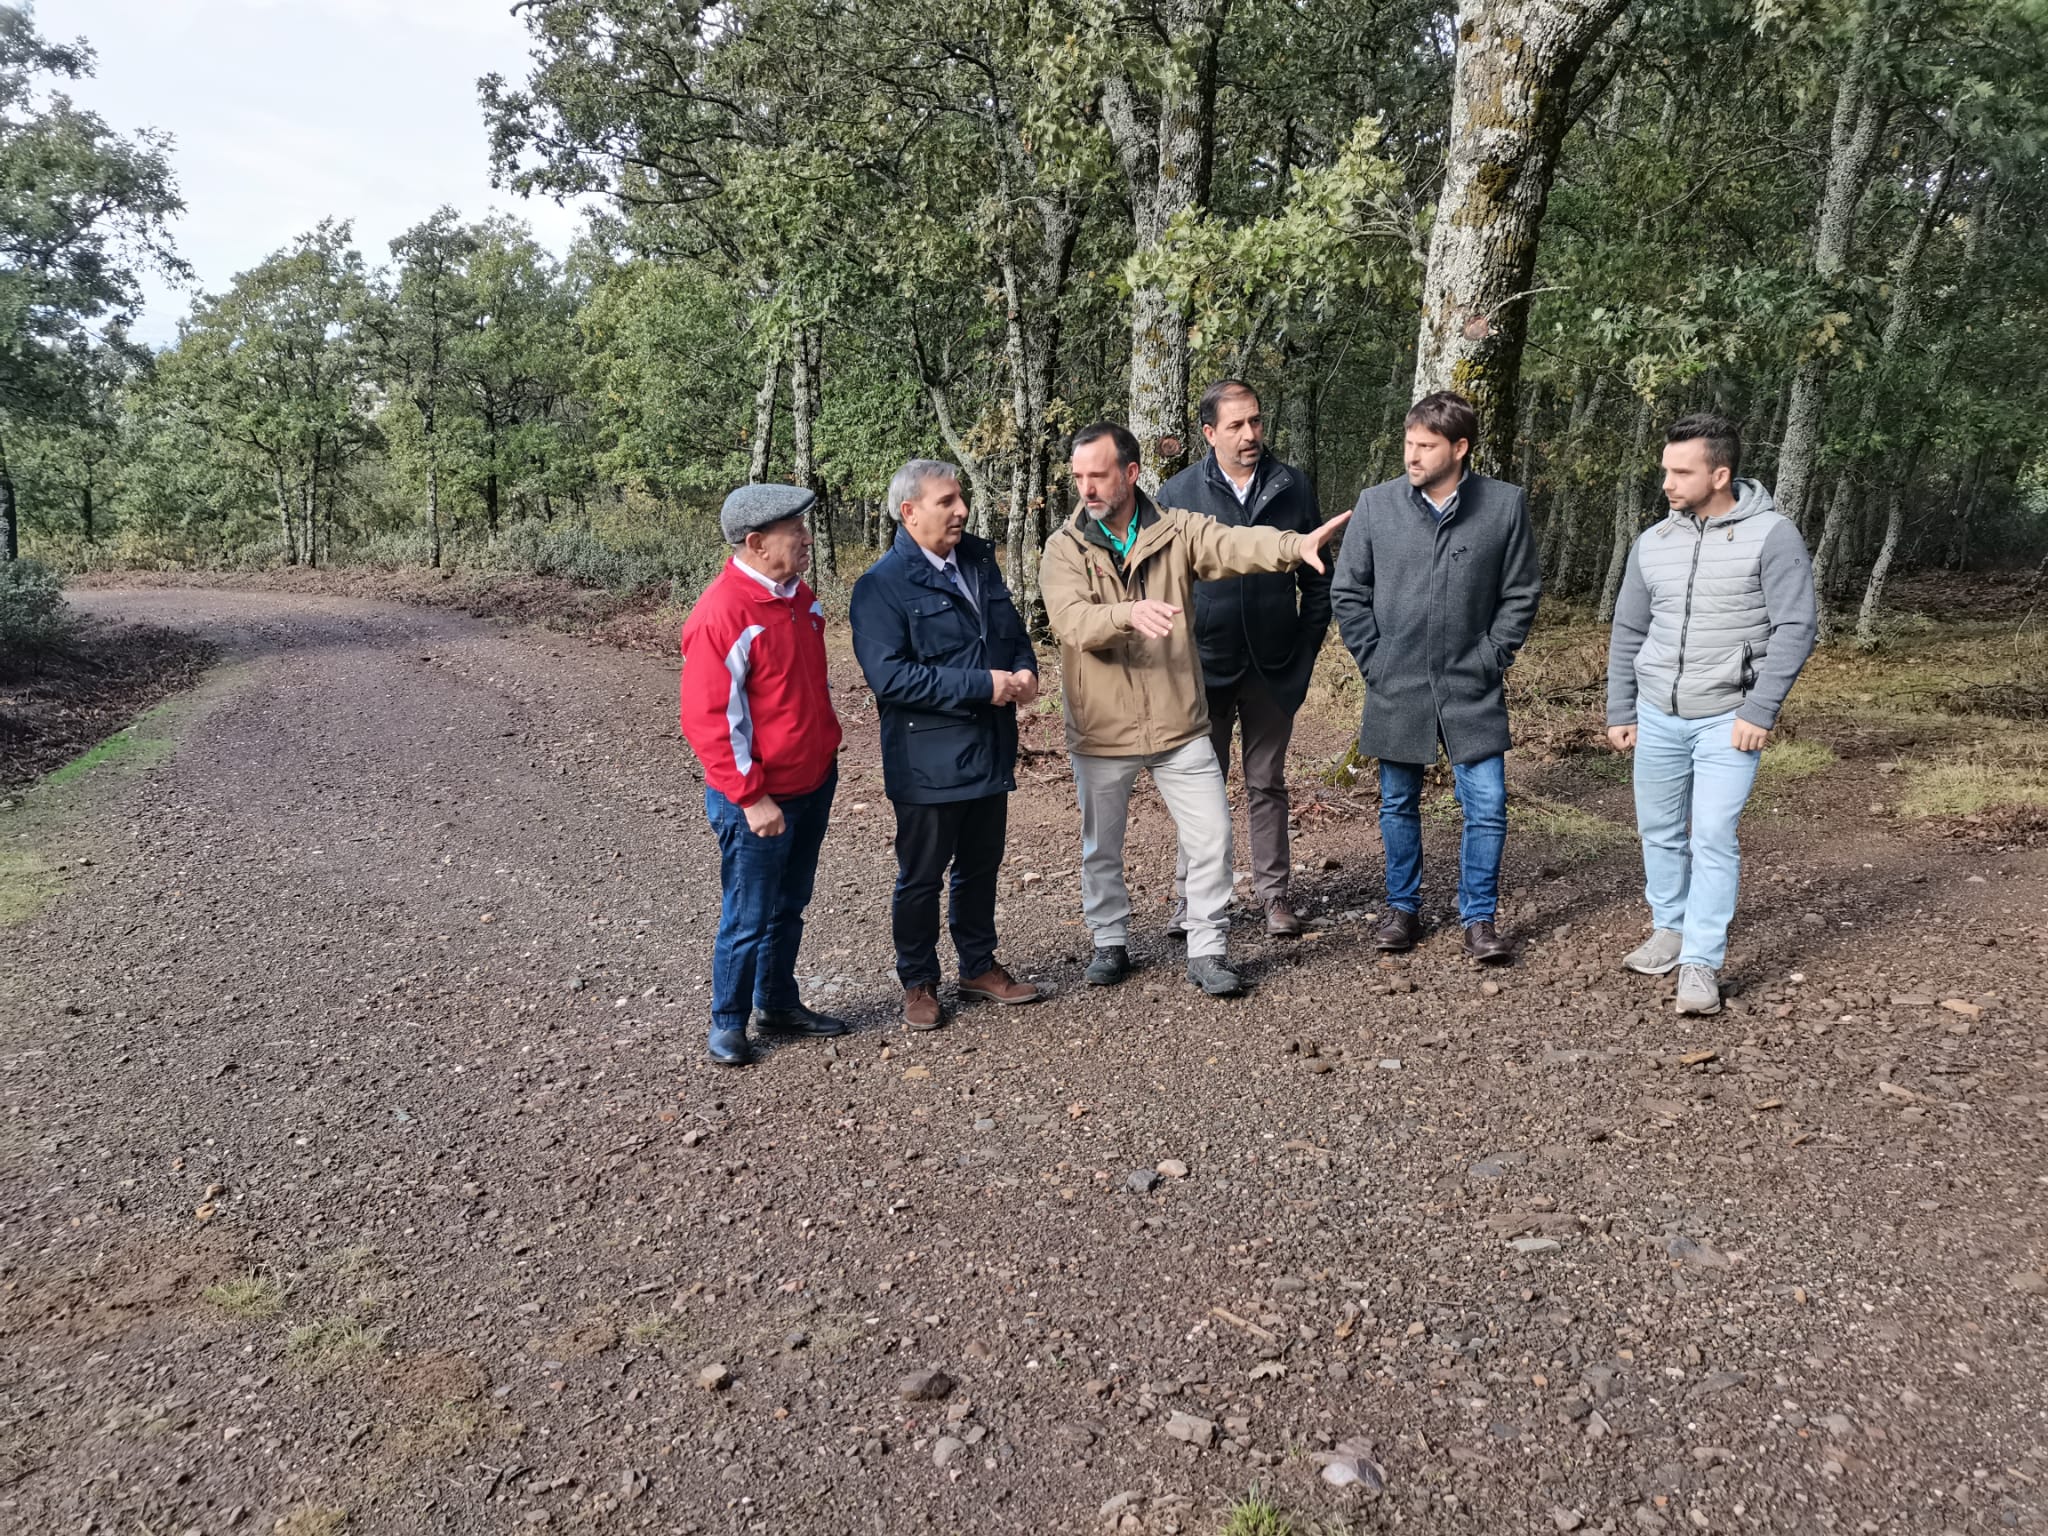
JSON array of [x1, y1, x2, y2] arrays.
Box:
[[1157, 379, 1329, 938]]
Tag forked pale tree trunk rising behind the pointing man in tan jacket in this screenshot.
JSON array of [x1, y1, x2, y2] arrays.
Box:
[[1102, 0, 1229, 489]]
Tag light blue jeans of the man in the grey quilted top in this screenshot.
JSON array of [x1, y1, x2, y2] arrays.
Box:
[[1636, 702, 1763, 971]]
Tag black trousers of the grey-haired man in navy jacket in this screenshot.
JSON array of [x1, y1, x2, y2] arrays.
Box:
[[889, 795, 1010, 987]]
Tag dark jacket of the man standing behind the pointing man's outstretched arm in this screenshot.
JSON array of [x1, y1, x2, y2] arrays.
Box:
[[1153, 453, 1329, 715]]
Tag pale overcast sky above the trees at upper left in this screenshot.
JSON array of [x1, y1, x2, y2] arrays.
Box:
[[48, 0, 580, 344]]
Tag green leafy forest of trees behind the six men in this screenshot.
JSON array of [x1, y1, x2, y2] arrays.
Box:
[[0, 0, 2048, 645]]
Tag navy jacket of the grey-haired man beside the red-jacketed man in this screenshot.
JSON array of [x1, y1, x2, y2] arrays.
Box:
[[852, 530, 1038, 805]]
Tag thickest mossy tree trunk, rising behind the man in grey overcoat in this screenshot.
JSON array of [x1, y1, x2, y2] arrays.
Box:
[[1415, 0, 1628, 471]]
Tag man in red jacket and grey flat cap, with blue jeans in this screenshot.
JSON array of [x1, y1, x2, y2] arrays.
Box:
[[682, 485, 846, 1067]]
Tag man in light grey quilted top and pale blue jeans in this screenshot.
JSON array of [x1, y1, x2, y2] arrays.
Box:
[[1608, 416, 1817, 1014]]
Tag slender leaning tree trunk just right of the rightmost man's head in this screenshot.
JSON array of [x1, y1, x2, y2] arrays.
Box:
[[1778, 0, 1888, 539]]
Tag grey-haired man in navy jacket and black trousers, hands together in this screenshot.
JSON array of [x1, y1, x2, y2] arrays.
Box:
[[852, 459, 1040, 1030]]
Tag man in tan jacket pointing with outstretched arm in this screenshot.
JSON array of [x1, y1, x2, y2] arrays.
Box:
[[1038, 422, 1352, 997]]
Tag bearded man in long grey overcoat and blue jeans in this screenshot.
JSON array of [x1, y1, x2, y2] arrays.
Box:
[[1329, 393, 1542, 963]]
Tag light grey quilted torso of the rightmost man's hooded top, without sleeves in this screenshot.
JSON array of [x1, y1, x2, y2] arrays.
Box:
[[1636, 479, 1784, 721]]
